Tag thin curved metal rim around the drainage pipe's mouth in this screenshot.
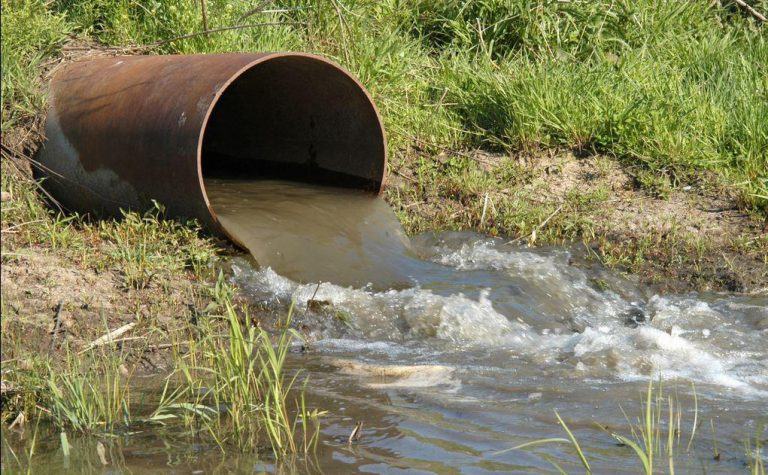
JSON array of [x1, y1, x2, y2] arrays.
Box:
[[196, 51, 388, 249]]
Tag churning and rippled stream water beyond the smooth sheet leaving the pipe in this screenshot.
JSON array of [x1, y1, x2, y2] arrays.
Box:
[[234, 233, 768, 473]]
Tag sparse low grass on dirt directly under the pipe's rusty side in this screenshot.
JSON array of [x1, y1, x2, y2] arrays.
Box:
[[2, 163, 218, 289]]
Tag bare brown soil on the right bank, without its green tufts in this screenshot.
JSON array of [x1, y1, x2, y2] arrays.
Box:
[[388, 152, 768, 293]]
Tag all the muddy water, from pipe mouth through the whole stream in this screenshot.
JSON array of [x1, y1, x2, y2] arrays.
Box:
[[3, 183, 768, 474]]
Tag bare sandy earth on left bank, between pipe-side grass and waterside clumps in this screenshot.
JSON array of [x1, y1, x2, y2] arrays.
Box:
[[2, 248, 202, 372]]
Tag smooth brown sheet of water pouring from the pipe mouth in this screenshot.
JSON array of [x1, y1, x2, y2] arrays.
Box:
[[205, 179, 432, 289]]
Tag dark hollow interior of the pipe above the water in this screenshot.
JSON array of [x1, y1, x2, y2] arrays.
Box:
[[201, 56, 386, 192]]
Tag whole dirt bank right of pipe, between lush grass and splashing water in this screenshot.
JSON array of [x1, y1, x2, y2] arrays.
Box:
[[386, 148, 768, 293]]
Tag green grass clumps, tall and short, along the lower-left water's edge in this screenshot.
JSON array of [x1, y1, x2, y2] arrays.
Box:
[[3, 291, 323, 460]]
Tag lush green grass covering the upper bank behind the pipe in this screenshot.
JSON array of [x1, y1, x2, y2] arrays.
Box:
[[3, 0, 768, 212]]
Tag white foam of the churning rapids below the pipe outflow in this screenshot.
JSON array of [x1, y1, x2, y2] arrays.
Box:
[[231, 240, 768, 397]]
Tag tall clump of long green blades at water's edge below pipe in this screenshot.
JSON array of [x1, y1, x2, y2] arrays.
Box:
[[168, 301, 322, 458]]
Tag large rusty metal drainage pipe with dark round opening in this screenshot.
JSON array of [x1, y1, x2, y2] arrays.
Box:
[[37, 53, 386, 246]]
